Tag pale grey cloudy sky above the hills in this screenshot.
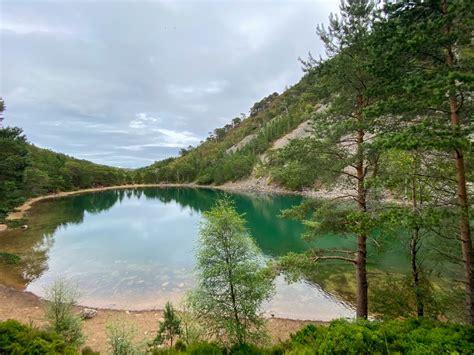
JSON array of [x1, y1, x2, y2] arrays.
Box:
[[0, 0, 339, 168]]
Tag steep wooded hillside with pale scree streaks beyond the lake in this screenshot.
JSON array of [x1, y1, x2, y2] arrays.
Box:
[[137, 72, 321, 189]]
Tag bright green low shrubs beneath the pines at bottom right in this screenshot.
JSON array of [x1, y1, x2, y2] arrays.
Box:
[[280, 319, 474, 354]]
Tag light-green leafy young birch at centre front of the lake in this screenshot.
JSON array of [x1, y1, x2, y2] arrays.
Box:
[[190, 199, 273, 344]]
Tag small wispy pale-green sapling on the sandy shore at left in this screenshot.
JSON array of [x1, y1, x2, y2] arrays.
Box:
[[45, 279, 85, 347]]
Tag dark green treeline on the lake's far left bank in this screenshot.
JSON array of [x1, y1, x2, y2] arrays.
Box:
[[0, 98, 131, 220]]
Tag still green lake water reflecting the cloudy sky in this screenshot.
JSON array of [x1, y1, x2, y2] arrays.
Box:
[[0, 188, 408, 320]]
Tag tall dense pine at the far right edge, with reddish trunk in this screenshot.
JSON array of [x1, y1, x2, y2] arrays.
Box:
[[369, 0, 474, 323]]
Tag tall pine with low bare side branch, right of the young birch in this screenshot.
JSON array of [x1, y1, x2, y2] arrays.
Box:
[[303, 0, 377, 318]]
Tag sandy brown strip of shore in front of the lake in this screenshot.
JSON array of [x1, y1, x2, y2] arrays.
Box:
[[0, 286, 315, 353]]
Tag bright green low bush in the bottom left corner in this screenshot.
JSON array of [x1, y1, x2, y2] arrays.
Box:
[[0, 320, 77, 354]]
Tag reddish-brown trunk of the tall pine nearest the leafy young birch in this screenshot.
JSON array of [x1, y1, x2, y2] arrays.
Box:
[[355, 130, 368, 319]]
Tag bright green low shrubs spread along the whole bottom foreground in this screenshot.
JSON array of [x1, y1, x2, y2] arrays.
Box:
[[0, 318, 474, 355]]
